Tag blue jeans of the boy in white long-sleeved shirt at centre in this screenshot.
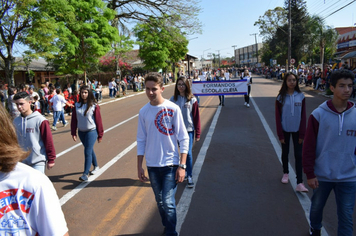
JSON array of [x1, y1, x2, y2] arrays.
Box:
[[147, 166, 178, 236]]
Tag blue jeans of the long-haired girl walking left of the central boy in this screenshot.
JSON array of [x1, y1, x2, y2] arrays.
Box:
[[78, 129, 98, 175]]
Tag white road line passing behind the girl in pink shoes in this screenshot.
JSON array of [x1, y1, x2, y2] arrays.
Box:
[[250, 96, 329, 236]]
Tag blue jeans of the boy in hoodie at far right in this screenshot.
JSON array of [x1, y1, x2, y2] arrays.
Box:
[[309, 181, 356, 236]]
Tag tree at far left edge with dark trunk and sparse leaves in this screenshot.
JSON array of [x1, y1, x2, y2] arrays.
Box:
[[0, 0, 60, 85]]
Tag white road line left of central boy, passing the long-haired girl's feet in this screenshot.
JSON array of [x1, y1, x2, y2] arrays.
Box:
[[59, 141, 137, 206]]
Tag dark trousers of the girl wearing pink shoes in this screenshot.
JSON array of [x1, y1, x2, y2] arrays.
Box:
[[282, 131, 303, 184]]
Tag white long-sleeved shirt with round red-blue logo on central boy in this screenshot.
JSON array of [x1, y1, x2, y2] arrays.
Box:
[[137, 100, 189, 167]]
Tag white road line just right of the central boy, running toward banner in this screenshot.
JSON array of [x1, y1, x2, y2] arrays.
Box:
[[176, 106, 221, 234]]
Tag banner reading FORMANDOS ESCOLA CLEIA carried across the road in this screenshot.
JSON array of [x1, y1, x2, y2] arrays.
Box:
[[192, 79, 247, 96]]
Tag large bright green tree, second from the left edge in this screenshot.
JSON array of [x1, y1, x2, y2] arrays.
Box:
[[49, 0, 119, 82]]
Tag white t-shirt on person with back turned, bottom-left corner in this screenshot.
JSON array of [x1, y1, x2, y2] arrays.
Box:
[[0, 162, 68, 236]]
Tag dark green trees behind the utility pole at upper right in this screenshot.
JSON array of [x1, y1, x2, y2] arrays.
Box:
[[255, 0, 337, 65]]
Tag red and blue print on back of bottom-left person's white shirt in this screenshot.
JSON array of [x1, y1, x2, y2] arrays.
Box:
[[0, 189, 35, 235]]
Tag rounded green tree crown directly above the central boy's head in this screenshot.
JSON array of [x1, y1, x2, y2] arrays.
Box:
[[134, 16, 188, 71]]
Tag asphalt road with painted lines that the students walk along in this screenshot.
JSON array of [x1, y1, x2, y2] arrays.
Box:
[[46, 76, 356, 236]]
